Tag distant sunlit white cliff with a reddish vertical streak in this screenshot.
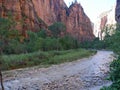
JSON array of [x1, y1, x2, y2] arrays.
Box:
[[94, 6, 116, 39]]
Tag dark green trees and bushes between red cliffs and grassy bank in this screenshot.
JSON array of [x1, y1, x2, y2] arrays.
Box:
[[0, 18, 79, 54]]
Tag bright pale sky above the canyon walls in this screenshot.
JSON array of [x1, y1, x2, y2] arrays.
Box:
[[64, 0, 116, 22]]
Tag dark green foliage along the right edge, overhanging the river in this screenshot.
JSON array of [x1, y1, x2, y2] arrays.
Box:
[[101, 25, 120, 90]]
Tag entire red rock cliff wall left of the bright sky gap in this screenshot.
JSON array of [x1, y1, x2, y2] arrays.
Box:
[[0, 0, 94, 41]]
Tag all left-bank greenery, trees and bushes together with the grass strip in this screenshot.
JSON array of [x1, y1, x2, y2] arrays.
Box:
[[0, 18, 95, 70]]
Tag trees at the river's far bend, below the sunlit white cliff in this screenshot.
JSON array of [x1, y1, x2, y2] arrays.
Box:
[[80, 25, 116, 49]]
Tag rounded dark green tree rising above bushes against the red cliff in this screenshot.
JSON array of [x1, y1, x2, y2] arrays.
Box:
[[48, 22, 66, 37]]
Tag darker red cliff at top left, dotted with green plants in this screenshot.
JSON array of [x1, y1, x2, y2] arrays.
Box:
[[0, 0, 46, 35]]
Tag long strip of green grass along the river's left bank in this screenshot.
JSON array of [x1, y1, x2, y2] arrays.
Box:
[[1, 49, 95, 70]]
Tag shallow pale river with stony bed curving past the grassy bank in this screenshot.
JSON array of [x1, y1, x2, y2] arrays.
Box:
[[0, 51, 113, 90]]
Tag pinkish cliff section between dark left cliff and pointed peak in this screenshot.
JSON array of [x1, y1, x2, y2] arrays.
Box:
[[32, 0, 68, 25]]
